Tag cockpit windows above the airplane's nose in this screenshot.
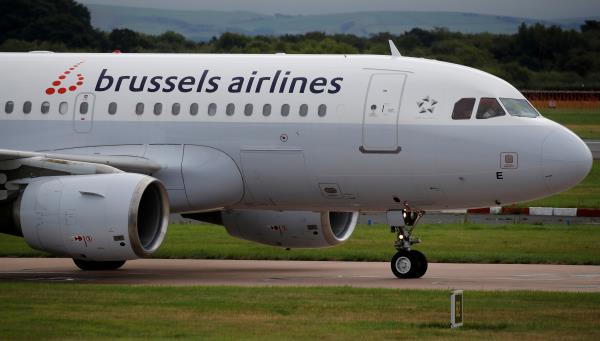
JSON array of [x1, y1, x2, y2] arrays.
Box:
[[452, 97, 539, 120]]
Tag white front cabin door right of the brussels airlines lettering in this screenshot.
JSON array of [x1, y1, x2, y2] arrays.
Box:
[[360, 73, 406, 153]]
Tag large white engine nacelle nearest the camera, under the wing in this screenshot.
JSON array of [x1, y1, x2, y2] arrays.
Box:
[[15, 173, 169, 261]]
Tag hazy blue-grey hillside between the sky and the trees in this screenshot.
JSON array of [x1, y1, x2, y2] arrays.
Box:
[[87, 4, 589, 41]]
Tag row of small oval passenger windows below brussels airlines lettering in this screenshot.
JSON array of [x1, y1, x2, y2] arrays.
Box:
[[4, 101, 327, 117]]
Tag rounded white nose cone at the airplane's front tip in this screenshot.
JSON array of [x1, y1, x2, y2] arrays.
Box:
[[542, 127, 593, 193]]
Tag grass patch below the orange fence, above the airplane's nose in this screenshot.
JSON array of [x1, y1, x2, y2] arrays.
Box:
[[540, 108, 600, 139]]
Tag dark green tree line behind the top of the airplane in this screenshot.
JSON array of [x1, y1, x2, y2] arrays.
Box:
[[0, 0, 600, 90]]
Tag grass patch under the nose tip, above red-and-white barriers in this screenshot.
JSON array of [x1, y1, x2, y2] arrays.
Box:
[[517, 160, 600, 208]]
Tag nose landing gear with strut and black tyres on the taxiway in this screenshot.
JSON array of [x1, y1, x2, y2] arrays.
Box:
[[387, 206, 427, 278]]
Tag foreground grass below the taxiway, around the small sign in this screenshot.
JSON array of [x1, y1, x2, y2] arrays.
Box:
[[0, 282, 600, 340]]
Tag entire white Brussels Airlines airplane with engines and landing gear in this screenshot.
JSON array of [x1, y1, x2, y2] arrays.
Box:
[[0, 42, 592, 278]]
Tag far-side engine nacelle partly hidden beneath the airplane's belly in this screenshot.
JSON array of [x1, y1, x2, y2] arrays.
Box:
[[221, 210, 358, 248]]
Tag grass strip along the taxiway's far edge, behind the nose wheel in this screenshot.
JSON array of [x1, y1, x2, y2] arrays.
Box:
[[0, 224, 600, 264]]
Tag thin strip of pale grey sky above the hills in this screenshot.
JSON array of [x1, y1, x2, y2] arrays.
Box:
[[76, 0, 600, 19]]
